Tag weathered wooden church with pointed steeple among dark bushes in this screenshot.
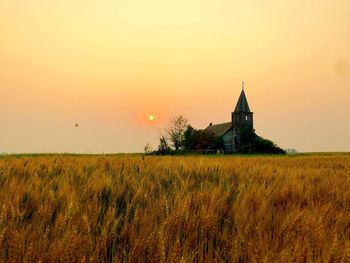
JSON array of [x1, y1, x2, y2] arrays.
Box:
[[205, 82, 254, 153]]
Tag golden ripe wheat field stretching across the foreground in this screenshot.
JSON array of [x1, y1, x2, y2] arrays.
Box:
[[0, 154, 350, 262]]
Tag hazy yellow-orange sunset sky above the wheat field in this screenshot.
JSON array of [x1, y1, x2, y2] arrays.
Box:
[[0, 0, 350, 153]]
